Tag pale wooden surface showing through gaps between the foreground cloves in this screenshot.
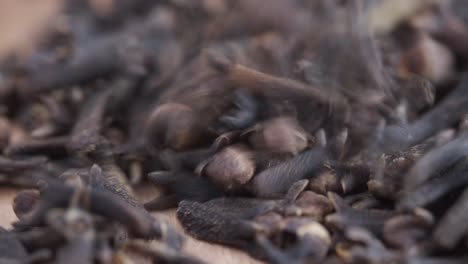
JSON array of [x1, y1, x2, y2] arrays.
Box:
[[0, 188, 261, 264]]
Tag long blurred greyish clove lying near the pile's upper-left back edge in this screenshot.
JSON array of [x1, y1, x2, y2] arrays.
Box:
[[19, 17, 159, 97]]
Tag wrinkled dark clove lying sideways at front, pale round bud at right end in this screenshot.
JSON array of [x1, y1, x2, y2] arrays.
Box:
[[177, 180, 329, 258]]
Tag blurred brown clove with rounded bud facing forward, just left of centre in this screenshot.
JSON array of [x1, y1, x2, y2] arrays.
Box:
[[145, 52, 233, 151]]
